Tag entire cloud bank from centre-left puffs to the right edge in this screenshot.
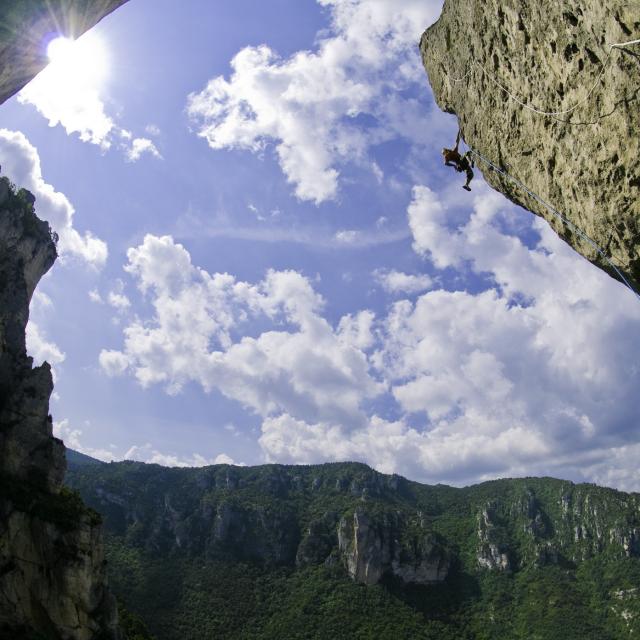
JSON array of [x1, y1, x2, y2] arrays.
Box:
[[101, 187, 640, 488]]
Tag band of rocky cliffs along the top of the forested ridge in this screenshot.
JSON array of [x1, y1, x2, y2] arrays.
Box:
[[68, 462, 640, 585]]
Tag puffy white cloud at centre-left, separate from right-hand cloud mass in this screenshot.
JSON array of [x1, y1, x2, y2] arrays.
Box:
[[100, 235, 381, 424]]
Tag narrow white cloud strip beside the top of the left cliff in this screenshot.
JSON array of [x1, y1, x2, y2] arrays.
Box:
[[0, 129, 107, 267]]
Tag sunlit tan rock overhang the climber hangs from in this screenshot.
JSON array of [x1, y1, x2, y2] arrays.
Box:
[[420, 0, 640, 291]]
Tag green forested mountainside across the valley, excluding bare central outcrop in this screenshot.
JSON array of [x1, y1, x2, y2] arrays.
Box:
[[69, 463, 640, 640]]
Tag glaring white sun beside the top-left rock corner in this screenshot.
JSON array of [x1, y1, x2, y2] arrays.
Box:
[[47, 33, 108, 88]]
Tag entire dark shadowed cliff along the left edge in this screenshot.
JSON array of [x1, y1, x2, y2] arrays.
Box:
[[0, 172, 119, 640]]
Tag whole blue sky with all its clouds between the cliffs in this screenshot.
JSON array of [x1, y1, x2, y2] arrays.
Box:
[[0, 0, 640, 490]]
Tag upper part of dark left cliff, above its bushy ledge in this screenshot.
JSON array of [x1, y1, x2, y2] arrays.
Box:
[[0, 178, 64, 492]]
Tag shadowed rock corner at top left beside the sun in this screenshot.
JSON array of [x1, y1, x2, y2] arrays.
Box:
[[0, 0, 127, 104]]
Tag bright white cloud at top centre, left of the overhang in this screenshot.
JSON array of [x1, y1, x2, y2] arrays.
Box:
[[187, 0, 442, 203]]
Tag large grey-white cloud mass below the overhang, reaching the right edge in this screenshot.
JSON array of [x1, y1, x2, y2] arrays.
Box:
[[260, 185, 640, 490]]
